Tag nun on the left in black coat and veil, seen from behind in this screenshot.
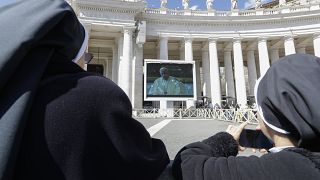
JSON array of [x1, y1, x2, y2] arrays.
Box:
[[0, 0, 169, 180]]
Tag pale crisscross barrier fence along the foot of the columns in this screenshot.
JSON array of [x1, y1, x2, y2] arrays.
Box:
[[132, 108, 258, 124]]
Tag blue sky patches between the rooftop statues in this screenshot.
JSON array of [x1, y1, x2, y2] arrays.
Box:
[[145, 0, 271, 10]]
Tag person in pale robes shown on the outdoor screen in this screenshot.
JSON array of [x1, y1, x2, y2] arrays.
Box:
[[148, 67, 186, 95]]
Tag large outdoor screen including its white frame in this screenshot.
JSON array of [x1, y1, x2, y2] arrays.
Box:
[[144, 60, 196, 101]]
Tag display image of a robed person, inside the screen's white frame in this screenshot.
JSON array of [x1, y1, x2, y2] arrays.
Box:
[[146, 63, 193, 97]]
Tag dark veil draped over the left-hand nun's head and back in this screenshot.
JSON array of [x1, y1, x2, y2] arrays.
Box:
[[0, 0, 85, 179]]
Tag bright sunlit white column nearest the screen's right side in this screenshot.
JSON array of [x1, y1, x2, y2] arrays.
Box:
[[209, 38, 221, 106]]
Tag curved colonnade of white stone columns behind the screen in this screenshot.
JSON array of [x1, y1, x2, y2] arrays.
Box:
[[108, 28, 320, 108]]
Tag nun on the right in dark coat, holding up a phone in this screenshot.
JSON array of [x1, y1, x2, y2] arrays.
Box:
[[172, 54, 320, 180]]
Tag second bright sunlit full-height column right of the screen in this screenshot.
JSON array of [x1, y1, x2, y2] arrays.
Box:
[[233, 39, 247, 107]]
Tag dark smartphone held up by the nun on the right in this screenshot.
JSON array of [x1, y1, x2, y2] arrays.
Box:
[[239, 129, 274, 149]]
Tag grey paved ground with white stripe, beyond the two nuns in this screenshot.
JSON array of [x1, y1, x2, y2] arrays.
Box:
[[138, 119, 261, 160]]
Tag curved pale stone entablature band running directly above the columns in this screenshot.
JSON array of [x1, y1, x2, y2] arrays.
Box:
[[146, 14, 320, 39]]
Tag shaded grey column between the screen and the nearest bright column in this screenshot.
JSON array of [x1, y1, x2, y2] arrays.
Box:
[[202, 47, 211, 98]]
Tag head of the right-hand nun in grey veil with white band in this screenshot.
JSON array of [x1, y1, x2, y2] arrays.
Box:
[[255, 54, 320, 151]]
